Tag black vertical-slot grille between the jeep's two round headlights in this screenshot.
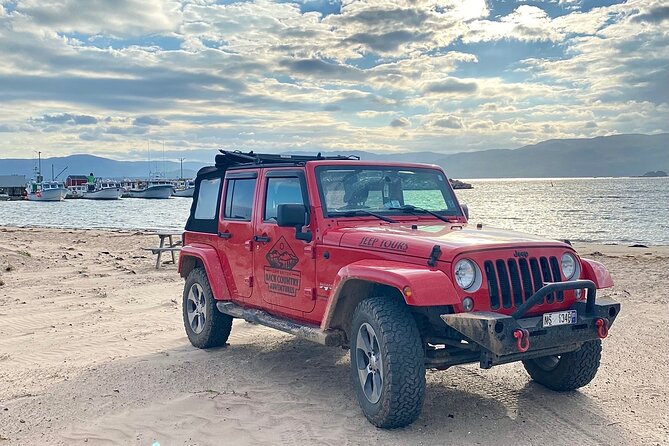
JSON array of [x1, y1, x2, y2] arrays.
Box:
[[483, 256, 564, 310]]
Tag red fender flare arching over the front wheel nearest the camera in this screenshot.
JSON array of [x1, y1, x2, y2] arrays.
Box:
[[321, 259, 461, 329]]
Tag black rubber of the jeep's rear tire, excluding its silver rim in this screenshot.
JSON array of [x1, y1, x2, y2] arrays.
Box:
[[181, 268, 232, 348]]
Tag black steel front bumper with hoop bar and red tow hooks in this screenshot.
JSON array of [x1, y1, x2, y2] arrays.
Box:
[[441, 280, 620, 369]]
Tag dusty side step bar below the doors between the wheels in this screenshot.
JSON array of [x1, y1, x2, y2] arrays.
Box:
[[216, 302, 346, 347]]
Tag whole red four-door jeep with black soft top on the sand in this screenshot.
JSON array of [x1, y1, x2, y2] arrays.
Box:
[[179, 151, 620, 428]]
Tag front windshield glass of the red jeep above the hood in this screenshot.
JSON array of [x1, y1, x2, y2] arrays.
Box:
[[316, 166, 462, 217]]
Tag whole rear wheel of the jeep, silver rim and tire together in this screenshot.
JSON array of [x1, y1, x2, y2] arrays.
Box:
[[182, 268, 232, 348]]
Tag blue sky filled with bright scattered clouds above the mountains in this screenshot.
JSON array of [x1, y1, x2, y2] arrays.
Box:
[[0, 0, 669, 162]]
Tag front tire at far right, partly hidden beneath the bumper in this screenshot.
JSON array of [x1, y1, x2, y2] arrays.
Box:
[[523, 339, 602, 392]]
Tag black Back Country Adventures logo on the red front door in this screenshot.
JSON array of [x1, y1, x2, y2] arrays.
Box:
[[265, 237, 301, 297]]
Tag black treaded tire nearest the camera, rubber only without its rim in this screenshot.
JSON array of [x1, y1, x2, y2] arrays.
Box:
[[351, 296, 425, 429]]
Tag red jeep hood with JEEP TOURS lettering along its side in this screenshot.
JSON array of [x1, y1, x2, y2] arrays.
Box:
[[323, 224, 571, 262]]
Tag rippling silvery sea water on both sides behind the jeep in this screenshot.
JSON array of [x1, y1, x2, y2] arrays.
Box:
[[0, 178, 669, 245]]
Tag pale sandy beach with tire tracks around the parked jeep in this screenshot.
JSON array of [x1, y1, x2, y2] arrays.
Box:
[[0, 227, 669, 445]]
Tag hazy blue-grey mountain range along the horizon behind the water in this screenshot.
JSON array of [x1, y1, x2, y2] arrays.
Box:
[[0, 133, 669, 178]]
